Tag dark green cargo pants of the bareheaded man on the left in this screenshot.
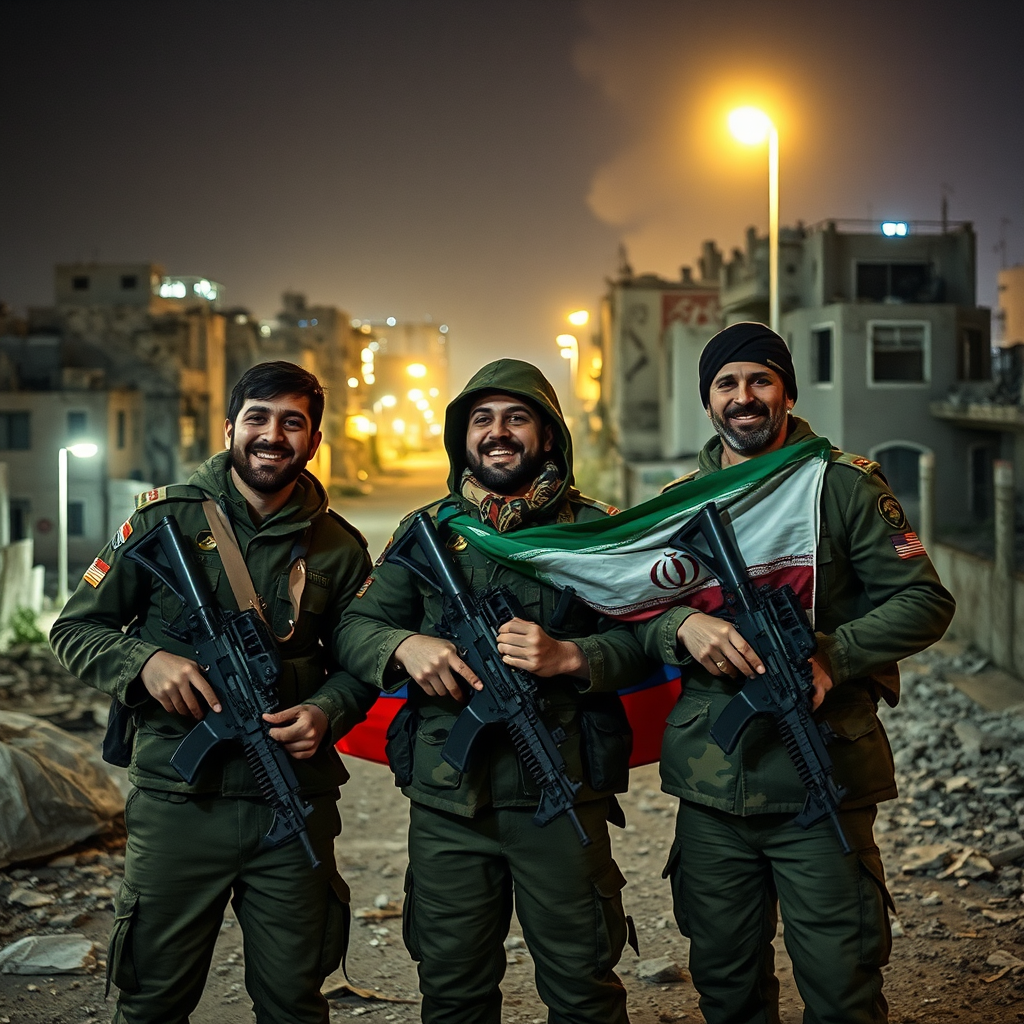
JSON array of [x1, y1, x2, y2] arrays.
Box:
[[108, 788, 349, 1024]]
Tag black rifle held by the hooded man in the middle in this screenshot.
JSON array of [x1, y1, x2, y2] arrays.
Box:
[[387, 512, 591, 846]]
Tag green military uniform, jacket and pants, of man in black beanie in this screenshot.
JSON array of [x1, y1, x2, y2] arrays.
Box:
[[643, 417, 953, 1024]]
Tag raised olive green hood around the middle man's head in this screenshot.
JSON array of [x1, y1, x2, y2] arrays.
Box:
[[444, 359, 572, 498]]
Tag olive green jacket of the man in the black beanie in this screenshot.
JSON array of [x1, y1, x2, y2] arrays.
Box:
[[640, 417, 954, 814]]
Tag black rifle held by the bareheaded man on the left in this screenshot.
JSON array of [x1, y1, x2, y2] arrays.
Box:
[[125, 515, 319, 867]]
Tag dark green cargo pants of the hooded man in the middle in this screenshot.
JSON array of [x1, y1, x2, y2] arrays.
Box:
[[402, 800, 635, 1024]]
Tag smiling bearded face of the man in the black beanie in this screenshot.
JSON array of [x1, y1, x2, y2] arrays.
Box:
[[707, 362, 794, 466]]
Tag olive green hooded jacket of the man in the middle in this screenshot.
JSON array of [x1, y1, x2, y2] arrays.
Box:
[[338, 359, 653, 817]]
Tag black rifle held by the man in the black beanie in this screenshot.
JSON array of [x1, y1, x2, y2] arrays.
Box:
[[669, 502, 850, 853]]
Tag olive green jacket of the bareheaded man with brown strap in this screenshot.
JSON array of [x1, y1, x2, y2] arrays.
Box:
[[50, 452, 377, 797]]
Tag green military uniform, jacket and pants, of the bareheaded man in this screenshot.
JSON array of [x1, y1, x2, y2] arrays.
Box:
[[50, 452, 376, 1024]]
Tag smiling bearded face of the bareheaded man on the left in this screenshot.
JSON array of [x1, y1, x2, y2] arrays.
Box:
[[224, 394, 321, 495]]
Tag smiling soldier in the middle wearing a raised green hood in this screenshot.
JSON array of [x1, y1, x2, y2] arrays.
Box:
[[339, 359, 651, 1024]]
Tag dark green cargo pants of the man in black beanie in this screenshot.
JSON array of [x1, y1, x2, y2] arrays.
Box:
[[665, 801, 892, 1024]]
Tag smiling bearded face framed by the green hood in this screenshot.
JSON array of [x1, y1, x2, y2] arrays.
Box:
[[466, 392, 554, 496]]
